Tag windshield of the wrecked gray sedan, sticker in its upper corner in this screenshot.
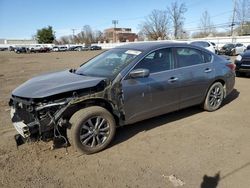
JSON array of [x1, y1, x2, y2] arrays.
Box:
[[76, 49, 141, 79]]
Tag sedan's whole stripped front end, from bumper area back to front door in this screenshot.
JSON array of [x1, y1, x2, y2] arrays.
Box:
[[9, 80, 124, 146]]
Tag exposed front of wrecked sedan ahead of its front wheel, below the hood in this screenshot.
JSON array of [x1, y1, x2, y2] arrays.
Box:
[[9, 96, 70, 146]]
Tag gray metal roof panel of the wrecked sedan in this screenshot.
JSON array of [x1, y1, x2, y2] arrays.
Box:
[[116, 41, 192, 51]]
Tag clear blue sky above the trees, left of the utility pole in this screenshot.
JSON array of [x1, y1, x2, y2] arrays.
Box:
[[0, 0, 233, 39]]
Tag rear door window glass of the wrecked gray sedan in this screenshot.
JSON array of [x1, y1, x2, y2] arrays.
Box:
[[176, 48, 205, 68]]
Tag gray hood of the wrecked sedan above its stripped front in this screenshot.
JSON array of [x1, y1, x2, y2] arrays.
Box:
[[12, 70, 105, 99]]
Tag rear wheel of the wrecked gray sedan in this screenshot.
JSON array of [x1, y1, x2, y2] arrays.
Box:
[[203, 82, 224, 112]]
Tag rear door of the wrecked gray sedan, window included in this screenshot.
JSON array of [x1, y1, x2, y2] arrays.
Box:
[[175, 47, 215, 108]]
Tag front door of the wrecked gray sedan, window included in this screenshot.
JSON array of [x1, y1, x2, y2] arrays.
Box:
[[122, 48, 180, 124]]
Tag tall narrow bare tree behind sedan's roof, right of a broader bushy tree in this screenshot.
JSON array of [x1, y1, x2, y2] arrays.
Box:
[[167, 0, 187, 39]]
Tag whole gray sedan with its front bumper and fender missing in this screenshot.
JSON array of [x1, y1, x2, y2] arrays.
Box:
[[9, 42, 235, 154]]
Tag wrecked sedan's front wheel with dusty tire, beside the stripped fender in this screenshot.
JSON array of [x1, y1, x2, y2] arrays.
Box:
[[67, 106, 116, 154]]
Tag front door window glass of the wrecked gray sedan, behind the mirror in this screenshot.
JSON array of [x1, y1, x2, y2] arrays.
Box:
[[134, 48, 173, 73]]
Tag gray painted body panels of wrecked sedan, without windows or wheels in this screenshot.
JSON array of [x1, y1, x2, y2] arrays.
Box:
[[12, 42, 234, 124]]
